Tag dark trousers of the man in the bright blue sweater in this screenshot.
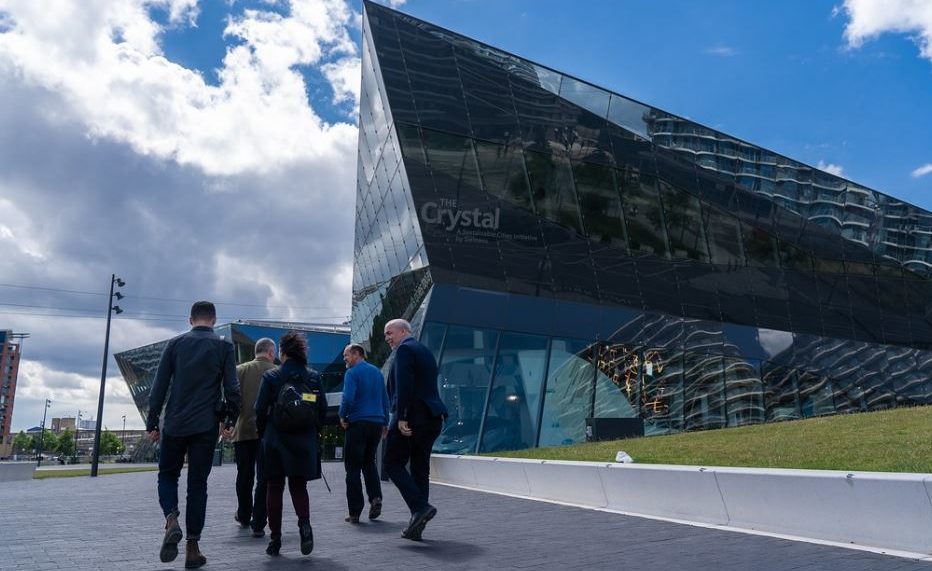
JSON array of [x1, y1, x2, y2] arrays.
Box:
[[343, 422, 382, 517]]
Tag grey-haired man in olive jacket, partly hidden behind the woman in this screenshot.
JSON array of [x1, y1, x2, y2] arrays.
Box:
[[233, 337, 275, 537]]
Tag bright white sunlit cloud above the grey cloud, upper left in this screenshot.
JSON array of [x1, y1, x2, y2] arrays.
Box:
[[0, 0, 358, 175]]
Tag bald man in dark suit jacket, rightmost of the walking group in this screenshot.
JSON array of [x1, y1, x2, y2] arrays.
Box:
[[384, 319, 447, 541]]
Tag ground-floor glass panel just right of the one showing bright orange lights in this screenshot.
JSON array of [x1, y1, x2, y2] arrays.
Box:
[[640, 348, 683, 435]]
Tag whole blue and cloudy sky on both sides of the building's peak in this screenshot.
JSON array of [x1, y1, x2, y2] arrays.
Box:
[[0, 0, 932, 431]]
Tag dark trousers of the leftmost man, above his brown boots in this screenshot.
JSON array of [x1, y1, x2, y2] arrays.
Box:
[[159, 428, 217, 539]]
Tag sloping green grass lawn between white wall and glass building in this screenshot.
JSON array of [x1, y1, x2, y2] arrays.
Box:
[[489, 406, 932, 473]]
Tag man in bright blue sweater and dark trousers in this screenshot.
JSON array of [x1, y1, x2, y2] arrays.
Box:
[[340, 343, 388, 523]]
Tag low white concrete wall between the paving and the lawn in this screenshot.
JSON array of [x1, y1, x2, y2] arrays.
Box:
[[431, 454, 932, 554]]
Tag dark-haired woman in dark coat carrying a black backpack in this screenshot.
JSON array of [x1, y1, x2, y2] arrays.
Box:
[[256, 331, 327, 555]]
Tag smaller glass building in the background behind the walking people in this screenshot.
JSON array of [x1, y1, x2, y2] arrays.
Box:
[[113, 320, 349, 421]]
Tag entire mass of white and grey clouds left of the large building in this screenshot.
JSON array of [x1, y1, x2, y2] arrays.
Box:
[[0, 0, 359, 430]]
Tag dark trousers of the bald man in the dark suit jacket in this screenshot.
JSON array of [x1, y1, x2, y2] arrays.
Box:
[[385, 417, 443, 513]]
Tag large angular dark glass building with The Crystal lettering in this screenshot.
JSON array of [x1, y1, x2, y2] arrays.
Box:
[[352, 2, 932, 453]]
